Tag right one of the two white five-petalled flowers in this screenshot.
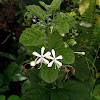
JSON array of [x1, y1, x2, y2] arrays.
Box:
[[46, 49, 62, 69]]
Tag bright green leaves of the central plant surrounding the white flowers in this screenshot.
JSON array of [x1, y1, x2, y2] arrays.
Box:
[[20, 0, 75, 84]]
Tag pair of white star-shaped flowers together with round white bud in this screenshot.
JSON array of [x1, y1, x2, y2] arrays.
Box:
[[30, 47, 62, 69]]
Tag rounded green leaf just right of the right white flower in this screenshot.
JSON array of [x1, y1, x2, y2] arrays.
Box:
[[56, 47, 75, 64]]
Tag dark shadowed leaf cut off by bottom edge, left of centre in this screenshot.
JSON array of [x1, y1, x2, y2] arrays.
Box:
[[22, 85, 49, 100]]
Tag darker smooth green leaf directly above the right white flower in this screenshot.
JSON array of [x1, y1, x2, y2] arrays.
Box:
[[48, 31, 63, 50]]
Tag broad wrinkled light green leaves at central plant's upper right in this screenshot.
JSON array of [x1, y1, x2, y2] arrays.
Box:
[[53, 12, 75, 30]]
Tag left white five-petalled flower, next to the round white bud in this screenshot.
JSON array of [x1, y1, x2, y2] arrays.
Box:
[[32, 47, 51, 64]]
